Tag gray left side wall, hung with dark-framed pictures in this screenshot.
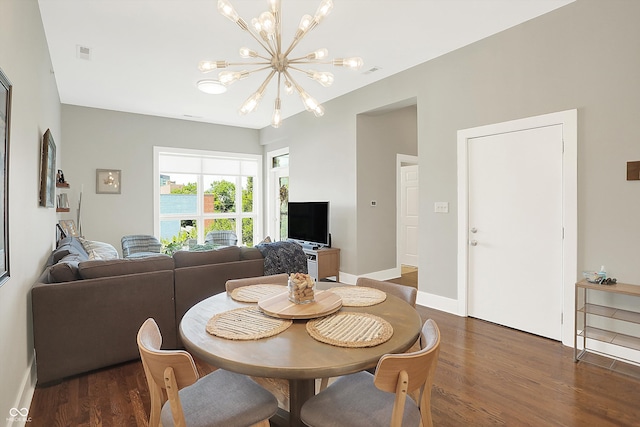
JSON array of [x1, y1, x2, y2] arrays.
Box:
[[0, 0, 64, 418]]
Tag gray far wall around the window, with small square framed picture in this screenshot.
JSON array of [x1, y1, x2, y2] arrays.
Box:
[[62, 105, 262, 251]]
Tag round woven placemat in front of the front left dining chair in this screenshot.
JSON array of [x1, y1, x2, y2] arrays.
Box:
[[207, 307, 293, 341]]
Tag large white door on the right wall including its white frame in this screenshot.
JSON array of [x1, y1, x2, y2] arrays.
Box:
[[458, 110, 577, 345]]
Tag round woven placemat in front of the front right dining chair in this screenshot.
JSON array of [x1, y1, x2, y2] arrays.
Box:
[[307, 312, 393, 348]]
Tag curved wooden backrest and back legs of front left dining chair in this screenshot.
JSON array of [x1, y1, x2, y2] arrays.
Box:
[[137, 318, 199, 427]]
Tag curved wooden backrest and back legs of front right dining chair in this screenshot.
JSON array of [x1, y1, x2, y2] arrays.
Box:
[[373, 319, 440, 427]]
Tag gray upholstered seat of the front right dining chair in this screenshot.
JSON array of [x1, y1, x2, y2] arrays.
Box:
[[300, 371, 420, 427]]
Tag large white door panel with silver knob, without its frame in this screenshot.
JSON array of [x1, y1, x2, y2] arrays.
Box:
[[467, 125, 563, 340]]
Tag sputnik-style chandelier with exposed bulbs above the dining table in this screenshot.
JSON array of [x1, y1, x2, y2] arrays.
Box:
[[198, 0, 362, 128]]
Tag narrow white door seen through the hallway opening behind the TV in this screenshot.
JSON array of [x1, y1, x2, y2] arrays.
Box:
[[398, 165, 418, 267]]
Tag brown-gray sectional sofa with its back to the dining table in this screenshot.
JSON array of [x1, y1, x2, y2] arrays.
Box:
[[31, 237, 264, 385]]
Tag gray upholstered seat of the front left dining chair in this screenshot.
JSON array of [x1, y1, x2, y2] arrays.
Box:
[[160, 369, 278, 427]]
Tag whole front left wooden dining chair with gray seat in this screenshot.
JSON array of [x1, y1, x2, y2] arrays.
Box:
[[137, 318, 278, 427]]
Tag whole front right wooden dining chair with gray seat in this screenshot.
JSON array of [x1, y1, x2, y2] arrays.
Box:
[[300, 319, 440, 427]]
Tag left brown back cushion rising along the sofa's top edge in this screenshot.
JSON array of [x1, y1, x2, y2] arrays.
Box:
[[78, 255, 174, 279]]
